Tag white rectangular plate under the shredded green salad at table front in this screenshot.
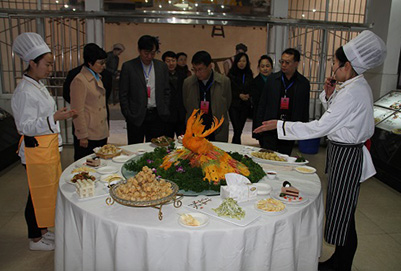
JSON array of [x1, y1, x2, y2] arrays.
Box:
[[184, 196, 260, 227]]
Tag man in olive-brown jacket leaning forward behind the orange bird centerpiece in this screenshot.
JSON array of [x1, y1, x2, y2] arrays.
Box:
[[183, 51, 231, 142]]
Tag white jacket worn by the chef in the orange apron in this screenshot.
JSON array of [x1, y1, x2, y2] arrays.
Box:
[[11, 75, 62, 164]]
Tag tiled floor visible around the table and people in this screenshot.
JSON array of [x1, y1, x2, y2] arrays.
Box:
[[0, 117, 401, 271]]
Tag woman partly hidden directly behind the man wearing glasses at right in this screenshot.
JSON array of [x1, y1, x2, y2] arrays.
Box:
[[251, 55, 273, 146]]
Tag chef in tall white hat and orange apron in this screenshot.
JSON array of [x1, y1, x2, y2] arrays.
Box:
[[11, 33, 75, 250]]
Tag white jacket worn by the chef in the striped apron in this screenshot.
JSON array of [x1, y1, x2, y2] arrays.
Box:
[[277, 75, 376, 182]]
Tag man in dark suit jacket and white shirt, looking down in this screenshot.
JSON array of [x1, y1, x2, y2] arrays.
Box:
[[119, 35, 170, 144]]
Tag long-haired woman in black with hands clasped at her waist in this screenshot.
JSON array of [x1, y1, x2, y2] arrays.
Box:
[[228, 53, 253, 144]]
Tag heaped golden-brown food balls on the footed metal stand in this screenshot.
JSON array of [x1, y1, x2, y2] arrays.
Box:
[[115, 167, 173, 201]]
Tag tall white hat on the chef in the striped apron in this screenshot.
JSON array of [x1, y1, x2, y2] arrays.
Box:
[[343, 30, 387, 74]]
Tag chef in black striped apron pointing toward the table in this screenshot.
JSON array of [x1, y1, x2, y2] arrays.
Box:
[[254, 30, 386, 271]]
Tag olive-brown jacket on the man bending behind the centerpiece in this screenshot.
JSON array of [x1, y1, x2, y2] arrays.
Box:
[[182, 71, 231, 142]]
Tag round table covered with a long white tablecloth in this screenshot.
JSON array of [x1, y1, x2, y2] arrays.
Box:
[[55, 142, 324, 271]]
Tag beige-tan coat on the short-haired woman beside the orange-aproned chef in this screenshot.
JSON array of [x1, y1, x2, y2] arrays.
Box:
[[70, 66, 109, 140]]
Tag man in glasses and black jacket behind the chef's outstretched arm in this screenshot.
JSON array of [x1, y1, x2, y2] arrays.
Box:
[[257, 48, 310, 155]]
